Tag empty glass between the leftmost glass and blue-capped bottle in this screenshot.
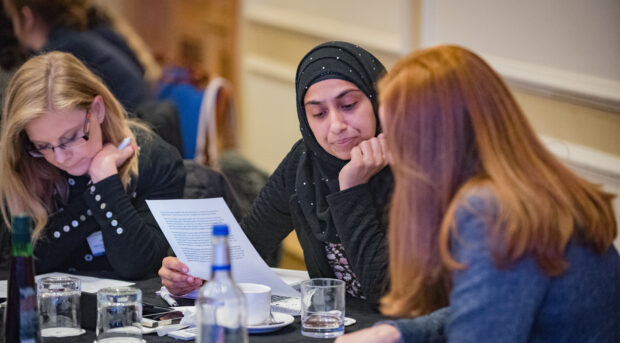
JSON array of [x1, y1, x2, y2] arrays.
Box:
[[96, 287, 143, 343]]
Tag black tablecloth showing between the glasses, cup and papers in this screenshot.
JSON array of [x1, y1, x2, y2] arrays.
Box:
[[0, 278, 386, 343]]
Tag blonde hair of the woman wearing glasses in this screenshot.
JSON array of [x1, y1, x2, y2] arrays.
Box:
[[0, 52, 146, 240]]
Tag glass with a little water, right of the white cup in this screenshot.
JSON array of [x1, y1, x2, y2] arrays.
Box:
[[300, 279, 345, 338]]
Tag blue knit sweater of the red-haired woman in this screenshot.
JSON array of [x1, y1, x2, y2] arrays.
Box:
[[391, 192, 620, 343]]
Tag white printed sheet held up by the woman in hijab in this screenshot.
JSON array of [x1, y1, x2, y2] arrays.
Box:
[[146, 198, 299, 297]]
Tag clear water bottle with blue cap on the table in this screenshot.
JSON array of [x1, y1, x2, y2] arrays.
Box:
[[196, 225, 248, 343]]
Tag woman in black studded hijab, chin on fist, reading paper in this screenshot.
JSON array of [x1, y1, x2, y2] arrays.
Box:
[[159, 42, 392, 304]]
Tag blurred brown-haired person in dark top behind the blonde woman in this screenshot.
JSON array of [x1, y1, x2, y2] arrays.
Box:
[[3, 0, 149, 112]]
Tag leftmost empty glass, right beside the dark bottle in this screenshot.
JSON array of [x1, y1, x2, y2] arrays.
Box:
[[37, 276, 86, 337]]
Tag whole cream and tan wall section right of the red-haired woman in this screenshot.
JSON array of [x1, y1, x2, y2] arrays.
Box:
[[420, 0, 620, 248]]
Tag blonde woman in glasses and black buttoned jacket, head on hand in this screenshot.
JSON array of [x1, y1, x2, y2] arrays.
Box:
[[0, 52, 185, 279]]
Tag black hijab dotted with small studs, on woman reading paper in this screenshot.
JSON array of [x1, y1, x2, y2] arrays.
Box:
[[295, 42, 391, 243]]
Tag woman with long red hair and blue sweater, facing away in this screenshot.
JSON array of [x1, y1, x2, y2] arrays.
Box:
[[338, 46, 620, 343]]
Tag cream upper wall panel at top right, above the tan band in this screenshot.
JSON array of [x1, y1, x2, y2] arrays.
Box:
[[422, 0, 620, 112]]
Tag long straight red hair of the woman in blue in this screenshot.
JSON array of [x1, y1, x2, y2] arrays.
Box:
[[379, 46, 617, 316]]
